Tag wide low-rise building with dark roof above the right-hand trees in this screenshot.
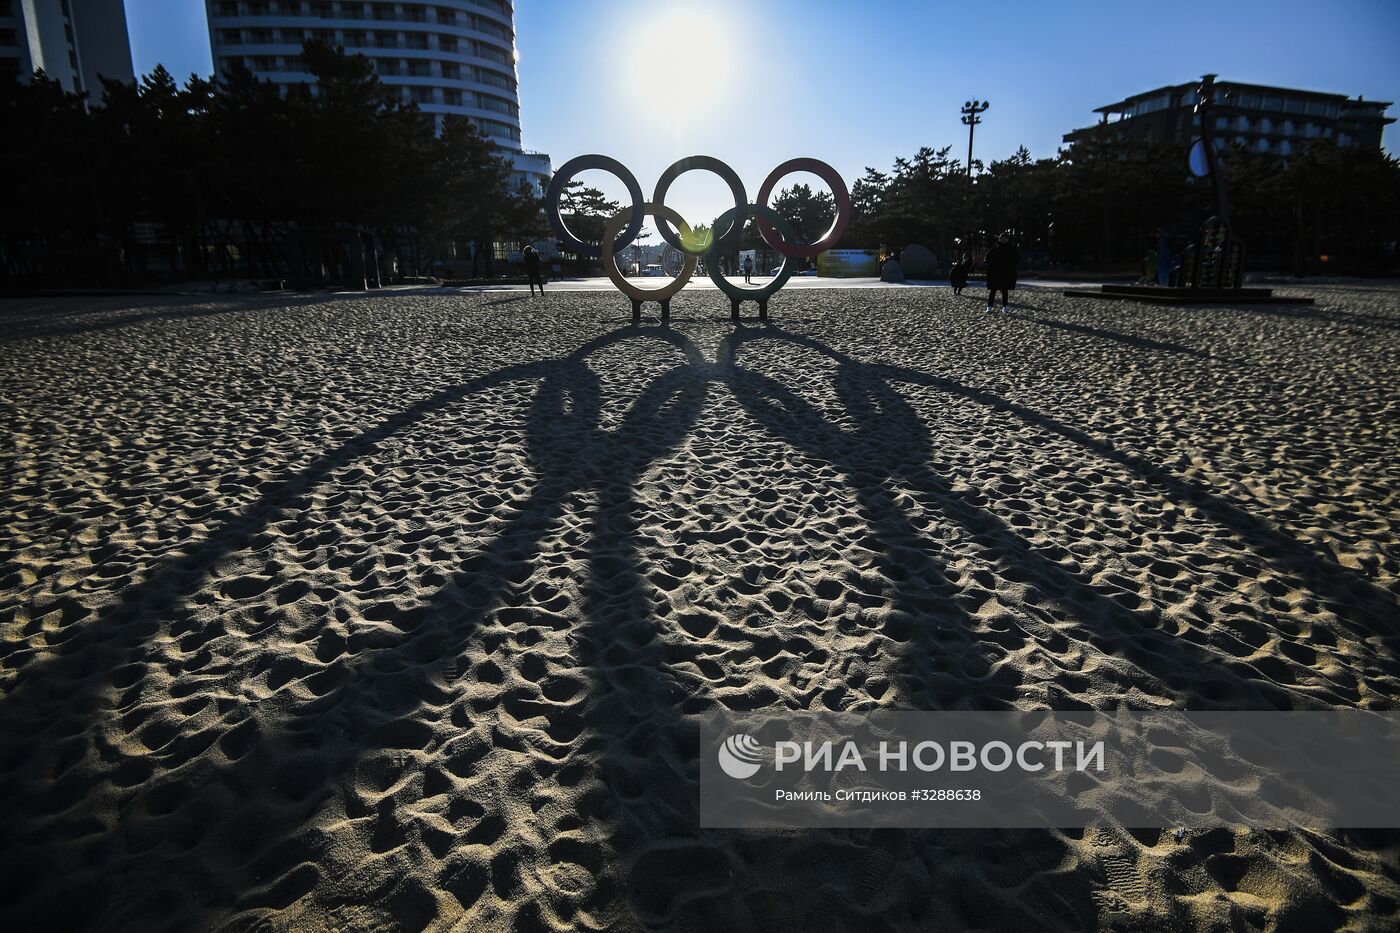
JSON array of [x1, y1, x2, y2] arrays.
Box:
[[1064, 81, 1394, 157]]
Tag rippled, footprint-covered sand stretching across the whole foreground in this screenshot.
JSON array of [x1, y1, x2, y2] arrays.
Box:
[[0, 284, 1400, 933]]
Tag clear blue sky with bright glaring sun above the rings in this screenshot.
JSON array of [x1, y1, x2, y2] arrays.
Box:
[[126, 0, 1400, 220]]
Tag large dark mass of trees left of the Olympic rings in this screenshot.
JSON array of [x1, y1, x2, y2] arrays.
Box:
[[0, 42, 545, 286]]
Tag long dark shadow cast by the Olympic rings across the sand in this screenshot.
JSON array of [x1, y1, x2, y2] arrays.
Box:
[[0, 308, 1394, 916]]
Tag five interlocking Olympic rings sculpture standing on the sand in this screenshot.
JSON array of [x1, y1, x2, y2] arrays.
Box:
[[545, 154, 853, 321]]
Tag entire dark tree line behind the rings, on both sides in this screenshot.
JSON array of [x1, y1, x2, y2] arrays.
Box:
[[0, 42, 1400, 287]]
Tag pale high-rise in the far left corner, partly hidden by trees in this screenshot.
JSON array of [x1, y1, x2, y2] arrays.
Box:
[[0, 0, 133, 99]]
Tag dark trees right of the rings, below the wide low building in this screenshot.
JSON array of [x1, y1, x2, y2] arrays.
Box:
[[843, 140, 1400, 275]]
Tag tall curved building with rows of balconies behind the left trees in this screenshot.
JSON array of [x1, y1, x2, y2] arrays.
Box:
[[206, 0, 550, 191]]
